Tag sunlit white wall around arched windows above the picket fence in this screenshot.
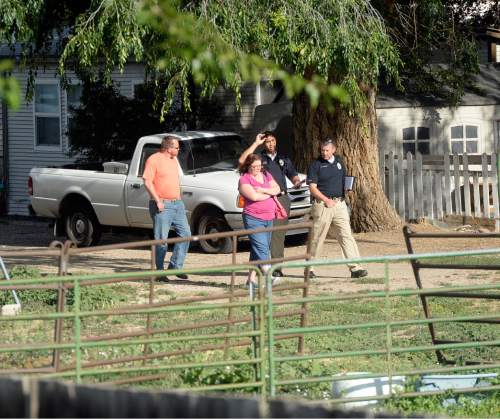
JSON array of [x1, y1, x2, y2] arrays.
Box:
[[377, 105, 500, 155]]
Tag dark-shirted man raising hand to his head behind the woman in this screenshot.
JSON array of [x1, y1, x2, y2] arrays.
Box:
[[238, 131, 302, 277]]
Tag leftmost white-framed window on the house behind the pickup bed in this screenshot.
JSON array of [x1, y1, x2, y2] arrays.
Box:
[[35, 83, 61, 147]]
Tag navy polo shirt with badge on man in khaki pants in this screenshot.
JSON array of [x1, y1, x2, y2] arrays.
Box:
[[307, 155, 346, 198]]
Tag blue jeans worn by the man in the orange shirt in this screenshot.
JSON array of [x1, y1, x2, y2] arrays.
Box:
[[149, 199, 191, 270]]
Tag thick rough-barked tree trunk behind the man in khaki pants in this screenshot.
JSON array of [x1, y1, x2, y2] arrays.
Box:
[[293, 89, 402, 232]]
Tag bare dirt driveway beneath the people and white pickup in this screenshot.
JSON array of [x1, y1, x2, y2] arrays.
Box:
[[0, 217, 500, 294]]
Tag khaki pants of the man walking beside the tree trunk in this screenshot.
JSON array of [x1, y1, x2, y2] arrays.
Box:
[[311, 200, 363, 272]]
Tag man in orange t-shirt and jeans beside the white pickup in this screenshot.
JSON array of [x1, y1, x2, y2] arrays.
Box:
[[146, 135, 191, 281]]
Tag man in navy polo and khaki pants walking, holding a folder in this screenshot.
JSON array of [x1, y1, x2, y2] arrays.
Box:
[[307, 140, 368, 278]]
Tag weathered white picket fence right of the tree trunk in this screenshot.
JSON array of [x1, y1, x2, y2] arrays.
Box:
[[379, 152, 499, 220]]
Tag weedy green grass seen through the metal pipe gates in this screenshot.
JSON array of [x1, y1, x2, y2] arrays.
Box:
[[0, 262, 500, 416]]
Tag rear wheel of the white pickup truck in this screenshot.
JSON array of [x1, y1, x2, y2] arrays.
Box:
[[64, 208, 101, 247]]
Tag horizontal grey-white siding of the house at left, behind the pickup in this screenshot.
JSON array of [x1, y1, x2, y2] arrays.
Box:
[[7, 65, 144, 215]]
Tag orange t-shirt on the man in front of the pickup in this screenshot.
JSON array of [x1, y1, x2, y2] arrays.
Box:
[[142, 152, 181, 199]]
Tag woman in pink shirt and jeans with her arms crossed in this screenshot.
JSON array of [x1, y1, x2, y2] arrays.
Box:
[[238, 154, 280, 283]]
